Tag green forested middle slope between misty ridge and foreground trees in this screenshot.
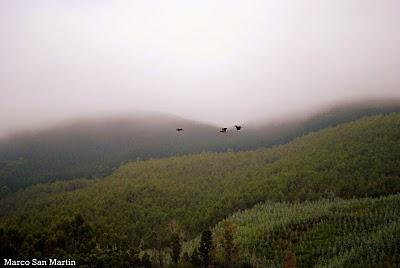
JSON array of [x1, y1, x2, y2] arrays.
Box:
[[0, 114, 400, 262]]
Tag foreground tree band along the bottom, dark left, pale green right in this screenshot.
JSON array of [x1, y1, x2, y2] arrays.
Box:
[[0, 195, 400, 268]]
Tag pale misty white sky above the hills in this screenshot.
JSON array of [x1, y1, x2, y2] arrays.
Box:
[[0, 0, 400, 135]]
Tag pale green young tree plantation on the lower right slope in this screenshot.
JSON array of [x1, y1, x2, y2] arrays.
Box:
[[209, 195, 400, 267]]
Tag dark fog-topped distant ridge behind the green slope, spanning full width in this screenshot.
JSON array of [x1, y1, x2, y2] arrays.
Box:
[[0, 101, 400, 193]]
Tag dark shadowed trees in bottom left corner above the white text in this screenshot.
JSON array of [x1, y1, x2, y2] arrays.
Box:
[[0, 214, 151, 267]]
